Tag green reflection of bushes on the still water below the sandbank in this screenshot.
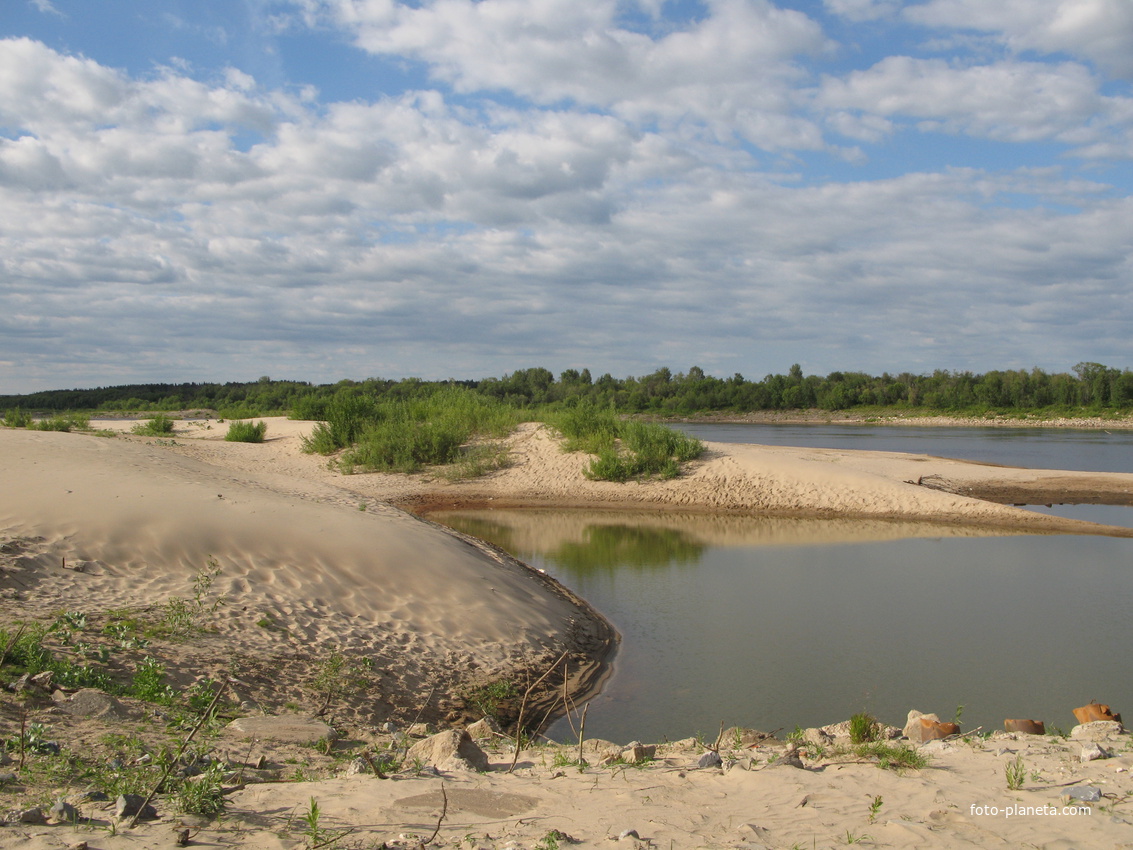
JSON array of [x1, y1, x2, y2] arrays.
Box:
[[544, 525, 706, 575]]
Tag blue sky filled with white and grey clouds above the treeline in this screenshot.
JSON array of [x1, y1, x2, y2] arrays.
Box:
[[0, 0, 1133, 393]]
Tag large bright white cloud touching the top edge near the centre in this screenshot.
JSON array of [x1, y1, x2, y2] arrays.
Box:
[[308, 0, 829, 150]]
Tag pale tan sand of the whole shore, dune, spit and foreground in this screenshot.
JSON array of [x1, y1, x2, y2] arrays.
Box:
[[0, 418, 1133, 850]]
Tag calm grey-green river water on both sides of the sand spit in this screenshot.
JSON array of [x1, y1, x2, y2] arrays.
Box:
[[433, 425, 1133, 742]]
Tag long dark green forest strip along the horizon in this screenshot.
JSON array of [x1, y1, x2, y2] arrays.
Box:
[[0, 363, 1133, 419]]
